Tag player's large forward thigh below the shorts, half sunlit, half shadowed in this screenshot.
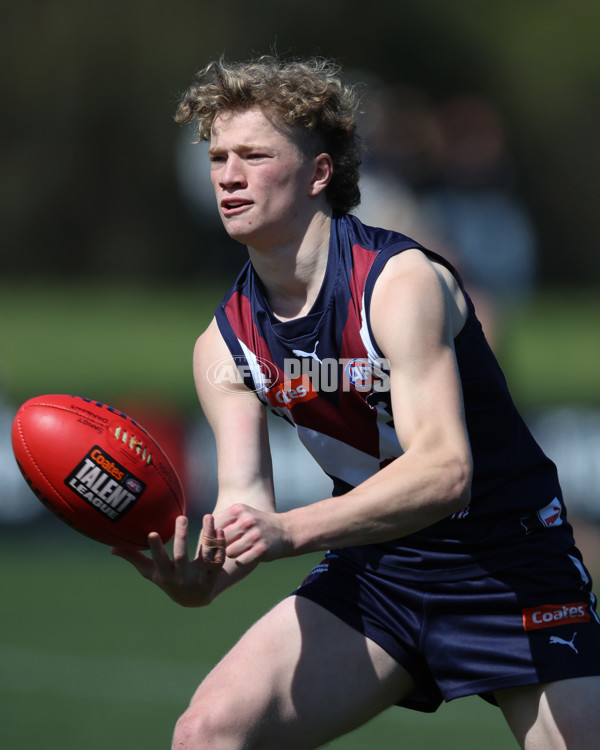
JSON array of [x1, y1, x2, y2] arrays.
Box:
[[190, 596, 414, 750]]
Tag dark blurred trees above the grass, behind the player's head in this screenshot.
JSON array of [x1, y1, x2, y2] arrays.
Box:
[[0, 0, 600, 287]]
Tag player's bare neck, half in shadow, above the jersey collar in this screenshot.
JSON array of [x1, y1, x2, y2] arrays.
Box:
[[249, 214, 331, 320]]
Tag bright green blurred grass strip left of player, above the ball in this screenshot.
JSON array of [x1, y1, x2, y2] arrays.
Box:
[[0, 280, 226, 408]]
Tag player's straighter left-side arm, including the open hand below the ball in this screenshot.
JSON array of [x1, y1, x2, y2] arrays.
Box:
[[112, 321, 281, 607]]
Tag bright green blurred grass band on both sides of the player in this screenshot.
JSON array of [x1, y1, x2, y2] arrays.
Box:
[[0, 280, 600, 409]]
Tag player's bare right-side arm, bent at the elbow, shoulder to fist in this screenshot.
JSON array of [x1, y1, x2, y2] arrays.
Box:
[[221, 251, 472, 563]]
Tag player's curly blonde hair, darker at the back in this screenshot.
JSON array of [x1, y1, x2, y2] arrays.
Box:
[[175, 55, 363, 213]]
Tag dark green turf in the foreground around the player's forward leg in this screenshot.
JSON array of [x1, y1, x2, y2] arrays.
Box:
[[0, 517, 515, 750]]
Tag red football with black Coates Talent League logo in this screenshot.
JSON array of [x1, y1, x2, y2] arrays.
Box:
[[12, 395, 185, 549]]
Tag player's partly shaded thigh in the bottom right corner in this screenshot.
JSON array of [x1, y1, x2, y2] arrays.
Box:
[[496, 676, 600, 750]]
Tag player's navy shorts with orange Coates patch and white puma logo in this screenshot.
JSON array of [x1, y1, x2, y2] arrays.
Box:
[[294, 549, 600, 712]]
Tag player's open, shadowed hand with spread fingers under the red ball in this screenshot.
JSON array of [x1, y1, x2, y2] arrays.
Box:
[[111, 515, 225, 607]]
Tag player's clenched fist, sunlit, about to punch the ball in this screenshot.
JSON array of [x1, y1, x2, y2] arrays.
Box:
[[215, 503, 290, 565]]
